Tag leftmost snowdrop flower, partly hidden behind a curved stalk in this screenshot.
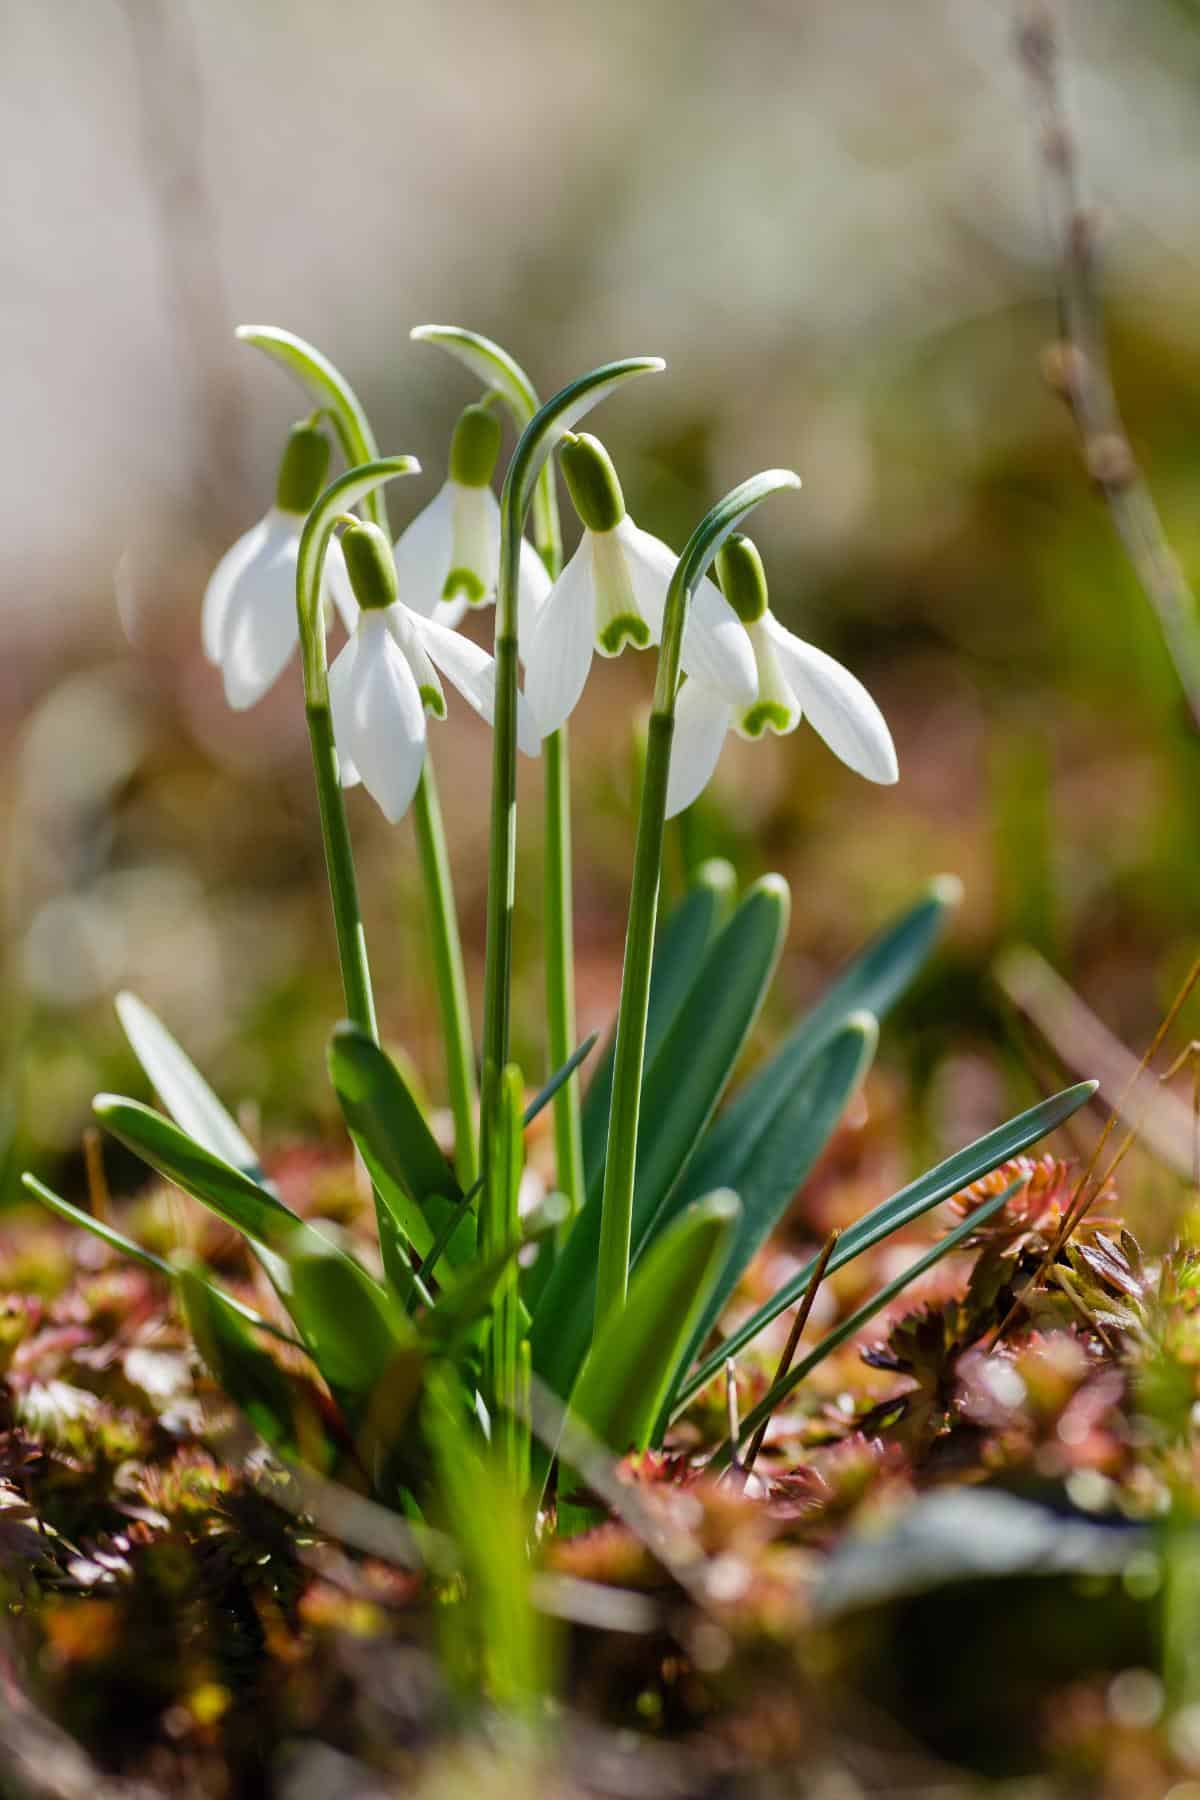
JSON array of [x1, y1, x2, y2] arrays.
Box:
[[201, 419, 354, 713]]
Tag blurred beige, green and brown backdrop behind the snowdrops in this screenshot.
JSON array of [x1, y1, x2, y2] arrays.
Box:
[[0, 0, 1200, 1193]]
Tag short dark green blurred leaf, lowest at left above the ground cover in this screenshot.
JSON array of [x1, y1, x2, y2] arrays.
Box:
[[175, 1256, 325, 1467]]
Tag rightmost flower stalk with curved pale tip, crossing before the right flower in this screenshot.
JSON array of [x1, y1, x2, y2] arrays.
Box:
[[596, 470, 801, 1332]]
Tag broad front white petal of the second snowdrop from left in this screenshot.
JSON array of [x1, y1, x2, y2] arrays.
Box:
[[347, 614, 425, 824]]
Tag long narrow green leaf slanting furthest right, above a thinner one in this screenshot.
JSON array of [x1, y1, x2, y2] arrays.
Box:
[[675, 1082, 1096, 1413]]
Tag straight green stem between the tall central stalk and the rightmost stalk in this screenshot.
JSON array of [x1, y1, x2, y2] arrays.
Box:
[[542, 725, 583, 1224]]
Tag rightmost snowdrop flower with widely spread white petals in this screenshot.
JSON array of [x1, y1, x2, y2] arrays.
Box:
[[667, 535, 898, 819]]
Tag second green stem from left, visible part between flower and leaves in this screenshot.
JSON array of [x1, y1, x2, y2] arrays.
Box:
[[412, 754, 479, 1188]]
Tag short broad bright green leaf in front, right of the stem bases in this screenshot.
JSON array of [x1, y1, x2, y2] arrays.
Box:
[[569, 1192, 741, 1456]]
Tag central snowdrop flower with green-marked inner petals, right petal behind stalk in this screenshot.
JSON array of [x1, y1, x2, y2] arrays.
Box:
[[522, 432, 757, 736]]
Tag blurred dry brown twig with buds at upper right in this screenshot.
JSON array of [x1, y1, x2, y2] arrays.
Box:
[[1016, 0, 1200, 729]]
